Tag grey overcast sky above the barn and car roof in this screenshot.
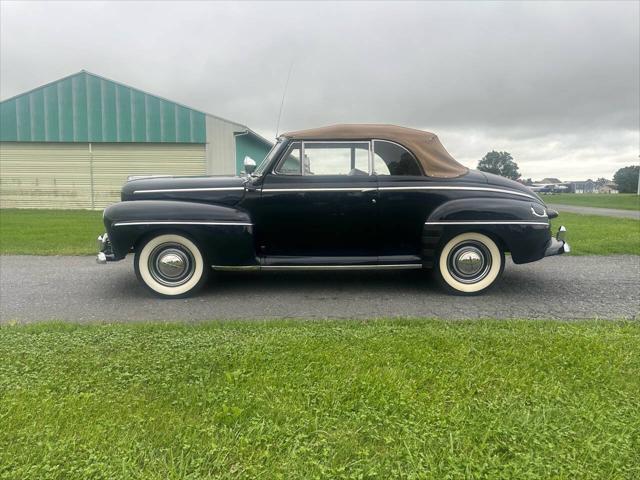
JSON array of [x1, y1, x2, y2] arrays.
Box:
[[0, 0, 640, 180]]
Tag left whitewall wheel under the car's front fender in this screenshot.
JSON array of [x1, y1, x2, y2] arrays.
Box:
[[134, 233, 209, 298]]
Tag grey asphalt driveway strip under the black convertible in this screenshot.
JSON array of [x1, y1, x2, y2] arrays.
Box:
[[0, 256, 640, 323]]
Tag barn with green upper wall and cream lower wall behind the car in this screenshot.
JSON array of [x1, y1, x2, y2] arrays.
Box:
[[0, 70, 271, 209]]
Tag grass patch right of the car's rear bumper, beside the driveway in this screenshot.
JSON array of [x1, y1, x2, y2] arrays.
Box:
[[551, 212, 640, 255]]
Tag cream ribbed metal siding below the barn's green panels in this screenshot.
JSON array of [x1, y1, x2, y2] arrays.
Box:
[[0, 142, 205, 208]]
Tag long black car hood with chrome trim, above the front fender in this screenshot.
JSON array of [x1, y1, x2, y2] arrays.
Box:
[[121, 177, 246, 205]]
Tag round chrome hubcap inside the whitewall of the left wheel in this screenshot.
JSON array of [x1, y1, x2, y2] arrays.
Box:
[[148, 243, 195, 287]]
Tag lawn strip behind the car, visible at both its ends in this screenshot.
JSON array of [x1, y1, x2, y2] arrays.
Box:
[[0, 209, 640, 255]]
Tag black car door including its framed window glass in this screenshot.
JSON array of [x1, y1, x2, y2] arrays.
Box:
[[256, 141, 378, 264]]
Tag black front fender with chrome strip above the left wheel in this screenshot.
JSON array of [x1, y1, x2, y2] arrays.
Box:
[[104, 200, 258, 265]]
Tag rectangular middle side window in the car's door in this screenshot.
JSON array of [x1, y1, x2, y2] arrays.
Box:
[[302, 142, 369, 175]]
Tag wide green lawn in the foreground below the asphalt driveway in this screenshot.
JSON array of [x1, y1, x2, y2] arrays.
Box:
[[0, 320, 640, 479]]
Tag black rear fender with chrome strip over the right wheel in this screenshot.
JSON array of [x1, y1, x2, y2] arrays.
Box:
[[423, 198, 551, 263]]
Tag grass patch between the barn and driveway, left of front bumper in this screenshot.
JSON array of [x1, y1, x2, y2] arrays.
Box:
[[0, 209, 104, 255]]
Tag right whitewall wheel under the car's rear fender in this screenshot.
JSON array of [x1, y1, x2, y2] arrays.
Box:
[[436, 232, 504, 295]]
